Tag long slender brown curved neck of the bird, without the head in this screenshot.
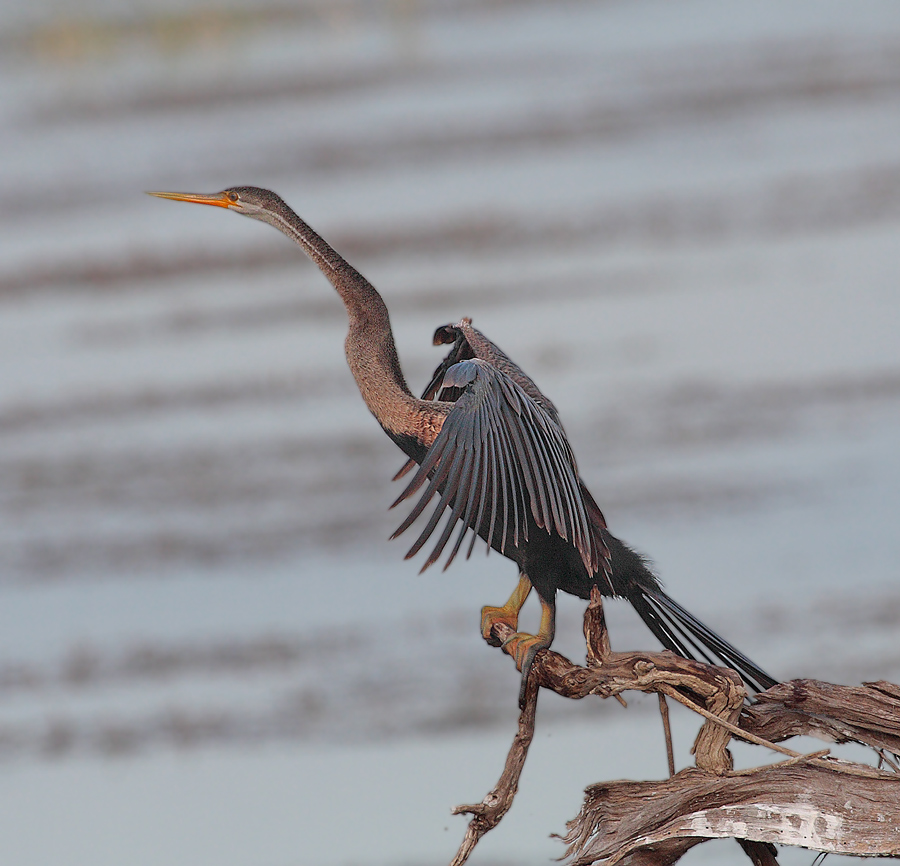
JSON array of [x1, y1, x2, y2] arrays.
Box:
[[266, 205, 442, 446]]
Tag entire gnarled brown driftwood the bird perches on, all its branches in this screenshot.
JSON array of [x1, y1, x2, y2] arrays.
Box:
[[452, 593, 900, 866]]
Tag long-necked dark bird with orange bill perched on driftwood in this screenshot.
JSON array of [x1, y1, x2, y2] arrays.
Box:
[[149, 186, 778, 706]]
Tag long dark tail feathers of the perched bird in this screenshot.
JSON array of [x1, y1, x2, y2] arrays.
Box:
[[627, 586, 778, 692]]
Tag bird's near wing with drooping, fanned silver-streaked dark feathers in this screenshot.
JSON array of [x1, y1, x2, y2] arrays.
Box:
[[392, 359, 605, 574]]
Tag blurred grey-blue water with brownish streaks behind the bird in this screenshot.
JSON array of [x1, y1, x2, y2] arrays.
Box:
[[0, 0, 900, 866]]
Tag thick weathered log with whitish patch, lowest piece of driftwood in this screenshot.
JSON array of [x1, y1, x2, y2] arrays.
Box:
[[566, 759, 900, 866]]
